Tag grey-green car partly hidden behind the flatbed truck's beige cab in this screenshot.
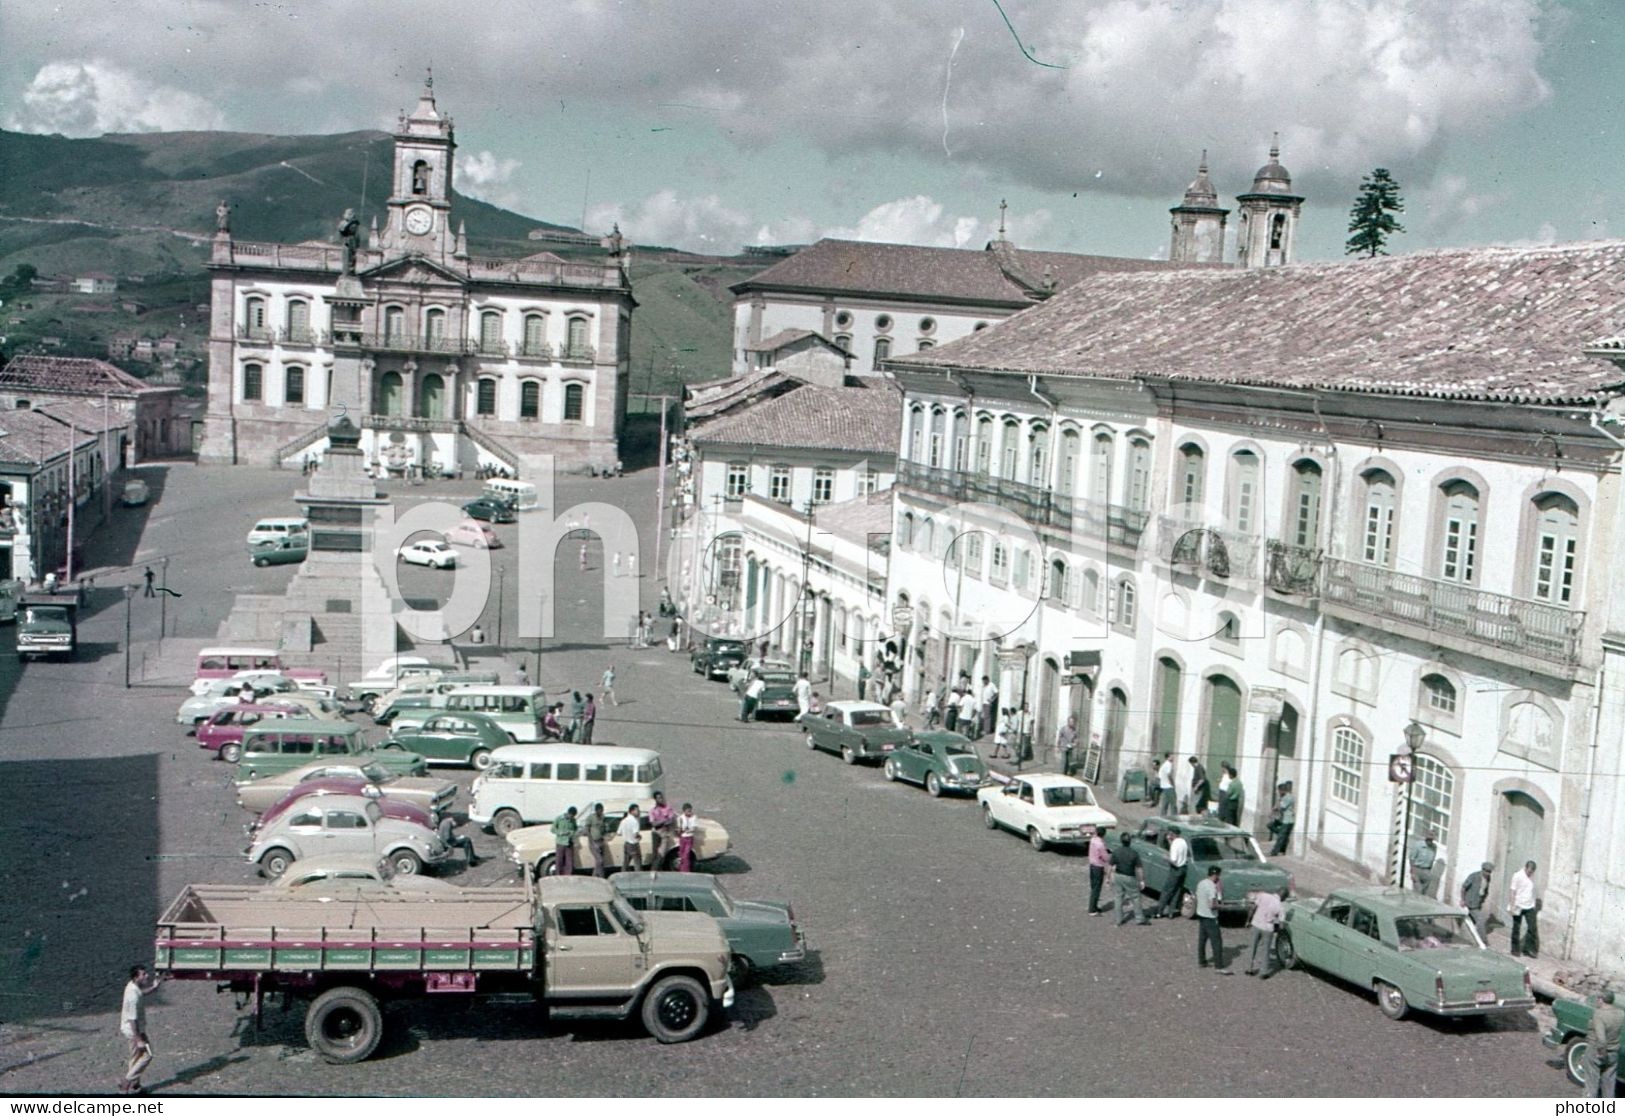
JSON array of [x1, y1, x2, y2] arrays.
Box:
[[613, 872, 808, 984]]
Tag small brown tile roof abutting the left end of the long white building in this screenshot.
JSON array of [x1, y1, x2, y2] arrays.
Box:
[[692, 383, 902, 456]]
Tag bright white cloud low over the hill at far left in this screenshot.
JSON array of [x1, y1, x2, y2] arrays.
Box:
[[7, 58, 226, 136]]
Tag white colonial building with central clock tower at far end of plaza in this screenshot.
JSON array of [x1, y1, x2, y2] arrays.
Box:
[[202, 80, 635, 473]]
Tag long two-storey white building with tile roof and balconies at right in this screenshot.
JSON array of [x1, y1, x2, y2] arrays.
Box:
[[887, 240, 1625, 962]]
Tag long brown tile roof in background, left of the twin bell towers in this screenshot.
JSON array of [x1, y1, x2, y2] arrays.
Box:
[[730, 240, 1191, 307]]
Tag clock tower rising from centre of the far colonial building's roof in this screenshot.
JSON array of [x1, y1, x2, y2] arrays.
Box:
[[379, 75, 457, 260]]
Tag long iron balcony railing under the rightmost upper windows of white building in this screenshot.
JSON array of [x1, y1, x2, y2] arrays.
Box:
[[1321, 559, 1586, 666]]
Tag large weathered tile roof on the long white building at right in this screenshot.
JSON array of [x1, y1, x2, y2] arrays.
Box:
[[891, 240, 1625, 403]]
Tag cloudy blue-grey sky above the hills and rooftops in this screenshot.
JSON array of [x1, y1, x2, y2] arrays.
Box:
[[0, 0, 1625, 258]]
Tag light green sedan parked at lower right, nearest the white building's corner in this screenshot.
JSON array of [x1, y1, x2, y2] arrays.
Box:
[[1276, 887, 1534, 1019]]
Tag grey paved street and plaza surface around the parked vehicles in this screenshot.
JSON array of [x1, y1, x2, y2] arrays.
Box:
[[0, 465, 1573, 1097]]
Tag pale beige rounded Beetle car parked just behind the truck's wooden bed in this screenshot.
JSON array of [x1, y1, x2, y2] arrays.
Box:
[[244, 794, 447, 879]]
